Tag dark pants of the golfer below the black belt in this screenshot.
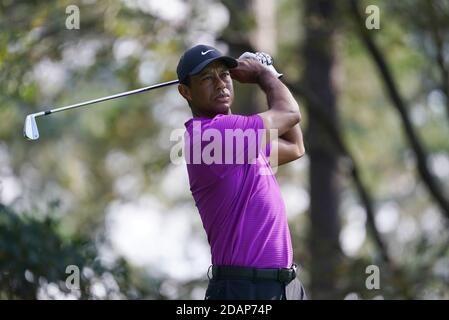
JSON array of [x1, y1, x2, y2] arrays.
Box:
[[205, 278, 307, 300]]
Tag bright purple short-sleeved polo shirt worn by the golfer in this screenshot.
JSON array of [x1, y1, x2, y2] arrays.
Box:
[[184, 115, 293, 268]]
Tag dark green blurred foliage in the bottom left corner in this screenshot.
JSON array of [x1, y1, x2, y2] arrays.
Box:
[[0, 204, 144, 299]]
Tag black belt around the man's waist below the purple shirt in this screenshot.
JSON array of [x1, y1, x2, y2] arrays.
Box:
[[212, 264, 297, 283]]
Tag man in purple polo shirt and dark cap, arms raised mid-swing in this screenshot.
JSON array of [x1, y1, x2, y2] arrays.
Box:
[[177, 45, 305, 300]]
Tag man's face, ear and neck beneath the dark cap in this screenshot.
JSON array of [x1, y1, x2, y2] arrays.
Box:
[[179, 61, 234, 117]]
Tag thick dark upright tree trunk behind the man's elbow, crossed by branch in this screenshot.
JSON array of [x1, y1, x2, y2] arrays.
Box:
[[302, 0, 341, 299]]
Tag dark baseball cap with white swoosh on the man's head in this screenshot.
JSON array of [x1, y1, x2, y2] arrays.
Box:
[[176, 44, 238, 83]]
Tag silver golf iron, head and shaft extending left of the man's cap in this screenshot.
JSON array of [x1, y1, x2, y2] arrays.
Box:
[[23, 80, 179, 140]]
